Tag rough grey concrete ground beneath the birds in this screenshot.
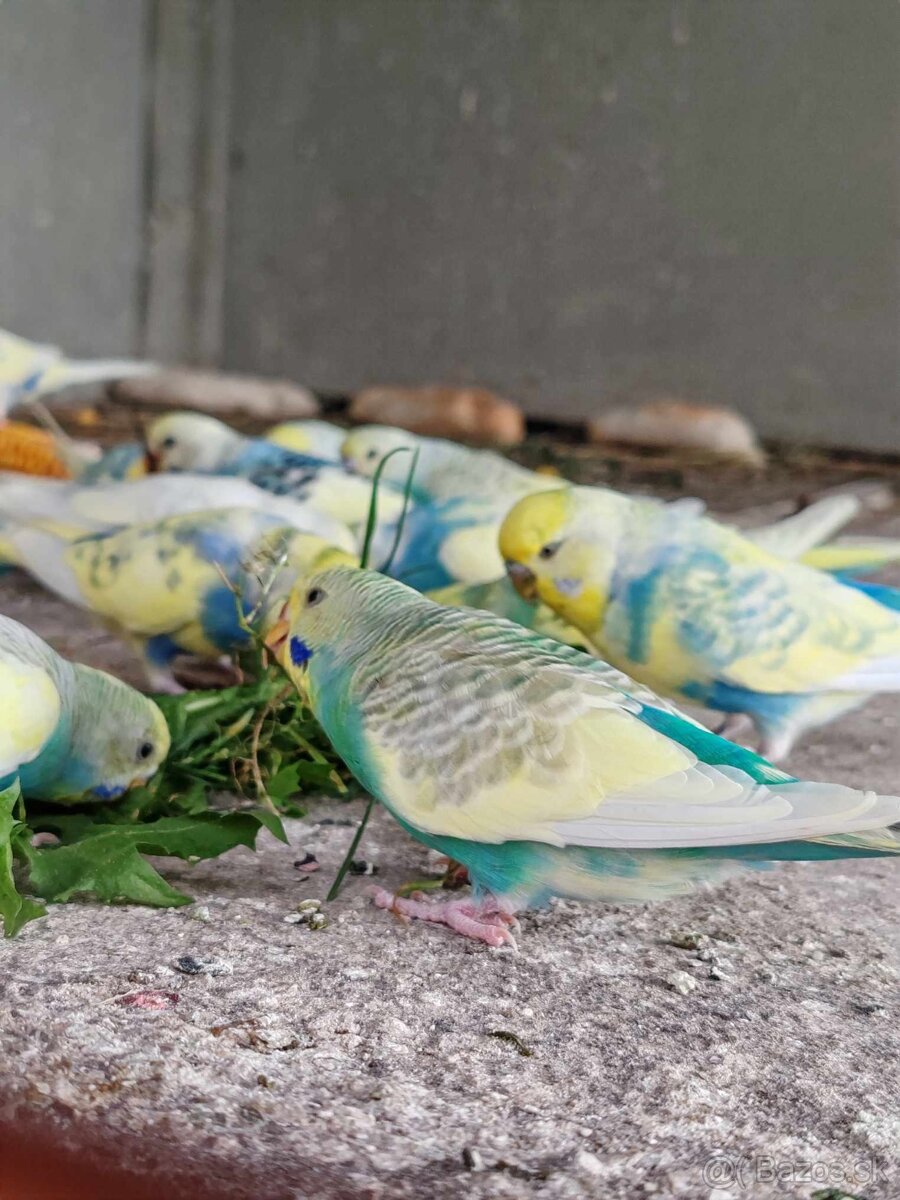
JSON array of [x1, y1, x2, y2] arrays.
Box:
[[0, 465, 900, 1200]]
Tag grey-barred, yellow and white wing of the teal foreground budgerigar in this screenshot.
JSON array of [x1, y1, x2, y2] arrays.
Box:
[[353, 614, 900, 847]]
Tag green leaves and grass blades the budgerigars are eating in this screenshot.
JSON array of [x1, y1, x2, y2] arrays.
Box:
[[0, 458, 415, 936]]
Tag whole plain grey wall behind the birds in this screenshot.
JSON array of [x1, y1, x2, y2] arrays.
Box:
[[0, 0, 900, 452]]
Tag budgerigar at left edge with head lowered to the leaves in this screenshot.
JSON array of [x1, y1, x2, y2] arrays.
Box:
[[0, 617, 169, 803]]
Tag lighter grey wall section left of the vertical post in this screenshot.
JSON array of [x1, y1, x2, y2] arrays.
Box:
[[0, 0, 148, 354]]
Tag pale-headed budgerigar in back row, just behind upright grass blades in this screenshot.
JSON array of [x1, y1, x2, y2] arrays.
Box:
[[341, 425, 559, 508]]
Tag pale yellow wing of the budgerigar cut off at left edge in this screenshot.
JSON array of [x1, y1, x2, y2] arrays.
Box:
[[0, 659, 62, 779]]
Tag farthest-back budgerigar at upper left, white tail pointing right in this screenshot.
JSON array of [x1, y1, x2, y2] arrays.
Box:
[[0, 329, 158, 416]]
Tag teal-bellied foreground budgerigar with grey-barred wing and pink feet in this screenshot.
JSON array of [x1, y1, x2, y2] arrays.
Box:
[[272, 568, 900, 946]]
